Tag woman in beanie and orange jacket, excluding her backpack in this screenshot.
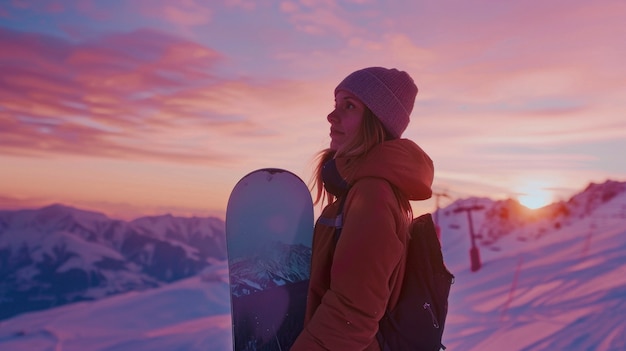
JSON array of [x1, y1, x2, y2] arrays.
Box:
[[291, 67, 434, 351]]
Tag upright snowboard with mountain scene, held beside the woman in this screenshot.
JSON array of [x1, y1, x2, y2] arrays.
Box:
[[226, 168, 313, 351]]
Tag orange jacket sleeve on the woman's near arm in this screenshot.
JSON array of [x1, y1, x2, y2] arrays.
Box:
[[292, 178, 404, 351]]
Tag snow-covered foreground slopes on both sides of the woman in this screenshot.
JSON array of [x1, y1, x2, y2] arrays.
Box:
[[0, 184, 626, 351]]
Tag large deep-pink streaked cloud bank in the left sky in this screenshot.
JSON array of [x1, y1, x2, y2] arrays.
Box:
[[0, 29, 278, 162]]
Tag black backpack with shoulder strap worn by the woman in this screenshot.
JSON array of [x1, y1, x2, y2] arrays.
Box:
[[335, 196, 454, 351]]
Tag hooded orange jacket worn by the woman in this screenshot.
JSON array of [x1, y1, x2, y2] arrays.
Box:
[[291, 139, 434, 351]]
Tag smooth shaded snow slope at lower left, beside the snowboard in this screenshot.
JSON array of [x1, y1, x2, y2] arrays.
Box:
[[0, 262, 231, 351]]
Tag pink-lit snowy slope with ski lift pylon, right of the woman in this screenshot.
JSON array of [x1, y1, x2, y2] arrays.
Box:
[[441, 182, 626, 351]]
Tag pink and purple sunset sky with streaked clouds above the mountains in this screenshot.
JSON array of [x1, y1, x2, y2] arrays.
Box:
[[0, 0, 626, 219]]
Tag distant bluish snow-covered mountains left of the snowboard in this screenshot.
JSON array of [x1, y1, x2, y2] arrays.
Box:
[[0, 205, 226, 319]]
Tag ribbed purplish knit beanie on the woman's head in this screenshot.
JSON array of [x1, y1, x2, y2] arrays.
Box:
[[335, 67, 417, 139]]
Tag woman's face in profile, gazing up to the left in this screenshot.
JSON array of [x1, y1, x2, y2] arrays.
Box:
[[328, 90, 366, 151]]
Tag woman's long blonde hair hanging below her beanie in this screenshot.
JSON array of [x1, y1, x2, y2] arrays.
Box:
[[313, 108, 413, 219]]
